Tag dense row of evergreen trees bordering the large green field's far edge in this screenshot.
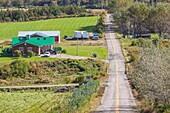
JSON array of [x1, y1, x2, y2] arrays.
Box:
[[0, 5, 87, 22]]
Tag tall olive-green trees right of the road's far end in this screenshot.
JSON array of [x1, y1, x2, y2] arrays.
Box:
[[108, 0, 170, 36]]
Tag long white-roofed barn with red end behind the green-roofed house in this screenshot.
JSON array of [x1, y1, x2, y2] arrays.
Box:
[[18, 31, 60, 43]]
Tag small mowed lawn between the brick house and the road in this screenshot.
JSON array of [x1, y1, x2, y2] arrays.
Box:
[[62, 46, 107, 59]]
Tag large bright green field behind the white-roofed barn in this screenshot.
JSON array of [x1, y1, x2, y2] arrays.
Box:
[[0, 16, 97, 40]]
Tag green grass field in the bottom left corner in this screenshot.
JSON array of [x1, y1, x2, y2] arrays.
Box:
[[0, 92, 68, 113]]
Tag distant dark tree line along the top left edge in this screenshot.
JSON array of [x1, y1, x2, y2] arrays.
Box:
[[0, 0, 108, 8]]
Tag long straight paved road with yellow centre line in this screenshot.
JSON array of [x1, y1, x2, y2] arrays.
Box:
[[96, 15, 137, 113]]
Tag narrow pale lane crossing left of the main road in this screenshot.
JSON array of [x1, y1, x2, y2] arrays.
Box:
[[0, 84, 79, 89]]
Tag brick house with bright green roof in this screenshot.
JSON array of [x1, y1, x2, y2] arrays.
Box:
[[12, 37, 55, 55]]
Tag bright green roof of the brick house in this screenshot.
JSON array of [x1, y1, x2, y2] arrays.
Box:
[[12, 37, 54, 47]]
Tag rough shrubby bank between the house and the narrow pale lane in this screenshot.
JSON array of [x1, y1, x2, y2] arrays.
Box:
[[0, 59, 107, 86]]
